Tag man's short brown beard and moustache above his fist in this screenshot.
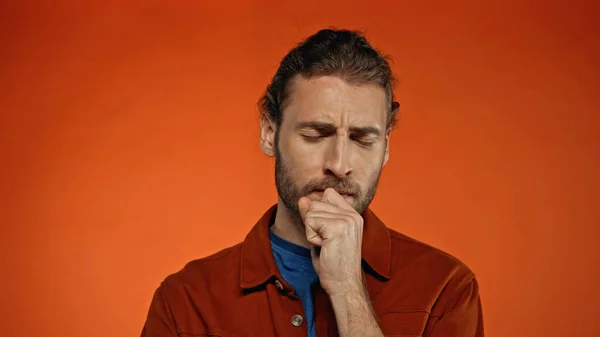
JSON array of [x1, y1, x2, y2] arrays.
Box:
[[275, 138, 381, 225]]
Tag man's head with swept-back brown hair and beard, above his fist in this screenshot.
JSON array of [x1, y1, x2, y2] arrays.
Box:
[[260, 29, 398, 222]]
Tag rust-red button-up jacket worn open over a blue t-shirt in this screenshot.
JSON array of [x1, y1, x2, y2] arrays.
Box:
[[141, 206, 483, 337]]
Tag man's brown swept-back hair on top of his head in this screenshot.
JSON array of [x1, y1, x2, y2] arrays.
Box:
[[259, 29, 399, 130]]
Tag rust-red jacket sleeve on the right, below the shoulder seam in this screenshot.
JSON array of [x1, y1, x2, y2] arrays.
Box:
[[426, 278, 484, 337]]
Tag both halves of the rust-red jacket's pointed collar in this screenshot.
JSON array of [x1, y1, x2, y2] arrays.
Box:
[[240, 205, 391, 289]]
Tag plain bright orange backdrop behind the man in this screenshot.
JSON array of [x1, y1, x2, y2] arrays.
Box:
[[0, 0, 600, 337]]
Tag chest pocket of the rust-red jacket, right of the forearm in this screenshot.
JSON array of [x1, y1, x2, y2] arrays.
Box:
[[379, 311, 429, 337]]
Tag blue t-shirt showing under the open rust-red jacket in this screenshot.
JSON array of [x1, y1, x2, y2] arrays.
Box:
[[269, 231, 319, 337]]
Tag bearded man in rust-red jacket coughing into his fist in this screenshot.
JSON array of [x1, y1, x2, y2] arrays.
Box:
[[142, 30, 483, 337]]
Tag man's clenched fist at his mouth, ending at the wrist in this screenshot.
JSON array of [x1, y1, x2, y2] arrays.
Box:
[[298, 188, 364, 296]]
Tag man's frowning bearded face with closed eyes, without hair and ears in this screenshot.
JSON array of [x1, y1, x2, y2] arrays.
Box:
[[263, 76, 388, 223]]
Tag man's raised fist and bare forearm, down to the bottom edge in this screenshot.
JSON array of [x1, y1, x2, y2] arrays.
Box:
[[298, 188, 383, 337]]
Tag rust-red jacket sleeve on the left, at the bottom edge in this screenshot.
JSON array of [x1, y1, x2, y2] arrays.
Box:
[[141, 283, 178, 337]]
